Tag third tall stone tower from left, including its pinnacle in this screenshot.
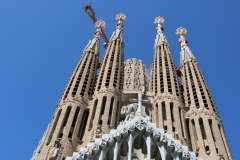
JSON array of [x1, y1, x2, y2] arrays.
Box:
[[150, 17, 187, 144]]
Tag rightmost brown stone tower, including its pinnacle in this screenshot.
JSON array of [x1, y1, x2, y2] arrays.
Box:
[[177, 27, 232, 160]]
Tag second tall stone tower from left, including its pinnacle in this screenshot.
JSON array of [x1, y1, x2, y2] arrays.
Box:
[[81, 13, 126, 143]]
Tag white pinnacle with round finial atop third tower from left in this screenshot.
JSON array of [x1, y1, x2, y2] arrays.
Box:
[[154, 16, 167, 47]]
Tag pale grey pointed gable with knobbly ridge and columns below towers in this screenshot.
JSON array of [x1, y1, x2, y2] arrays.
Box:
[[66, 116, 202, 160]]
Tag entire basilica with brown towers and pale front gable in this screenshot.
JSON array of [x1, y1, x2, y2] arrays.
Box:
[[31, 5, 233, 160]]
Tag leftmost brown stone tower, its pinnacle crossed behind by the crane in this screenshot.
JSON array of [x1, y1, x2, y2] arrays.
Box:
[[30, 20, 105, 160]]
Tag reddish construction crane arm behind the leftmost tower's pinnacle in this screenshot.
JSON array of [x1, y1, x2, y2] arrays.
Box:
[[83, 4, 109, 48]]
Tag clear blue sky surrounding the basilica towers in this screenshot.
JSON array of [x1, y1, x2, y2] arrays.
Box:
[[0, 0, 240, 160]]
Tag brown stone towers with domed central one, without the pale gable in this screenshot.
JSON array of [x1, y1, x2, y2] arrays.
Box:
[[32, 14, 232, 160]]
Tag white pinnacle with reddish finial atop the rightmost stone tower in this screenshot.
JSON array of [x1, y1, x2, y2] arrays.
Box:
[[176, 27, 196, 65]]
